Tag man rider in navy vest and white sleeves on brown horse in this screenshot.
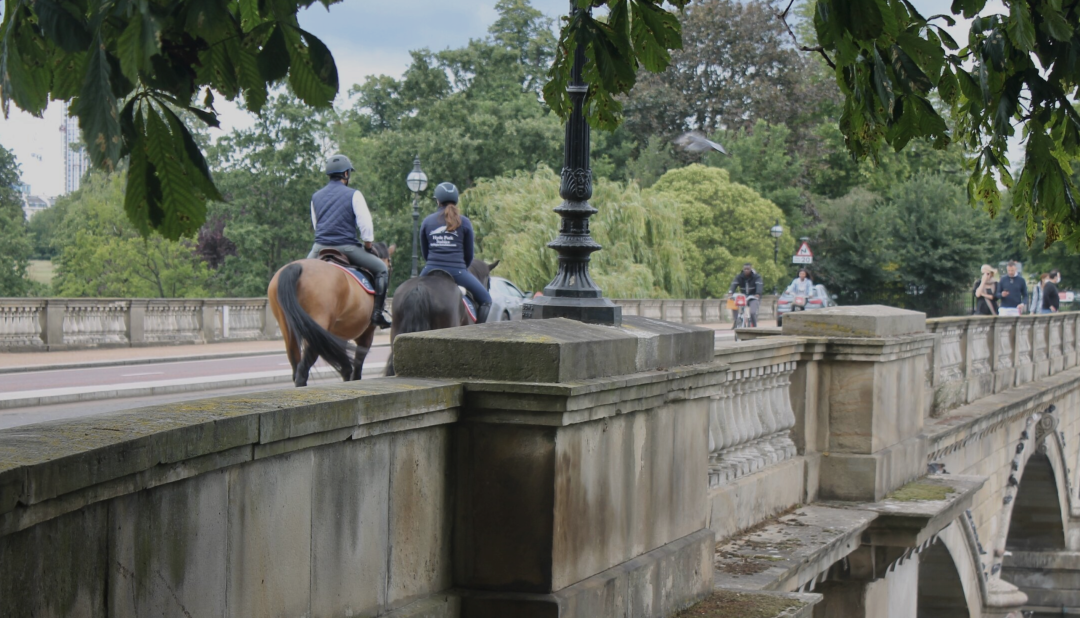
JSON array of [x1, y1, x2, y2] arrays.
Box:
[[308, 155, 390, 328]]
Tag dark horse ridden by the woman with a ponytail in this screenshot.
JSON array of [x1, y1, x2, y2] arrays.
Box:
[[386, 259, 499, 376]]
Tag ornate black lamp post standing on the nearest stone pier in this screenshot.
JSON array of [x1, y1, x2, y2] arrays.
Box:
[[522, 0, 622, 326]]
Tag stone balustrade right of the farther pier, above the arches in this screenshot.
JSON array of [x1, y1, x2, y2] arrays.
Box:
[[927, 312, 1080, 417]]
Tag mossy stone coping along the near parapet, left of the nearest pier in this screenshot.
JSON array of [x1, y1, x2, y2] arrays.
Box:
[[0, 379, 462, 514]]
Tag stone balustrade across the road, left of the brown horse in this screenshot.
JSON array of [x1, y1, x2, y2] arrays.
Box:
[[0, 298, 281, 351]]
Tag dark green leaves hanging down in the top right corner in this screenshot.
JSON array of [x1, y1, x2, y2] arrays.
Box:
[[814, 0, 1080, 248]]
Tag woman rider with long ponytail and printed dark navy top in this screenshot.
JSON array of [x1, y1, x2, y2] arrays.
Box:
[[420, 183, 491, 324]]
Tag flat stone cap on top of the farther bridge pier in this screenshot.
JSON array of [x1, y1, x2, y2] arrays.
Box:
[[781, 305, 927, 338]]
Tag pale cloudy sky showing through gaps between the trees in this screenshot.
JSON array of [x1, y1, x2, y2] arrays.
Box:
[[0, 0, 1000, 196]]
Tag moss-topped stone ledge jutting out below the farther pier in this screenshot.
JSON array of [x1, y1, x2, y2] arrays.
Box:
[[822, 474, 986, 548]]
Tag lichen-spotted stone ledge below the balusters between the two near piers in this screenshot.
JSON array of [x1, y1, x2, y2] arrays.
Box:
[[713, 505, 878, 591]]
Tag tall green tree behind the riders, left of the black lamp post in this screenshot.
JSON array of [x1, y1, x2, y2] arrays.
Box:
[[335, 0, 570, 284]]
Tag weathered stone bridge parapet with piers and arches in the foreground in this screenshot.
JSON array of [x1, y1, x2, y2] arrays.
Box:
[[0, 307, 1080, 618]]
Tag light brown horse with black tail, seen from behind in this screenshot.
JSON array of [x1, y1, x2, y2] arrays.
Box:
[[267, 242, 396, 387]]
